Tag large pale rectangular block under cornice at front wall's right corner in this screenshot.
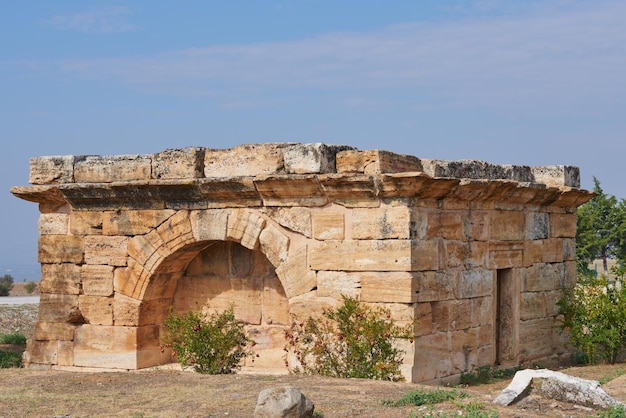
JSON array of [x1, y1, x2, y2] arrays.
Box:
[[352, 207, 411, 240]]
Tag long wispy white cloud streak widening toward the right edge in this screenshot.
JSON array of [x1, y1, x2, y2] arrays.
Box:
[[54, 1, 626, 111]]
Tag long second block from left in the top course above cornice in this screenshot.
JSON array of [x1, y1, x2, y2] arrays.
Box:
[[74, 155, 152, 183]]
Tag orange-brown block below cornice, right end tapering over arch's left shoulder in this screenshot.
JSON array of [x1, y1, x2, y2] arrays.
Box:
[[101, 209, 175, 236]]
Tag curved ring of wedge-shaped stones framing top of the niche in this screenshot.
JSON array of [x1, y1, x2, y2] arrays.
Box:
[[116, 208, 317, 306]]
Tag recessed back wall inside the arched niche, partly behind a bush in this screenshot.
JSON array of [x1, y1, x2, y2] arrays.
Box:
[[172, 241, 290, 371]]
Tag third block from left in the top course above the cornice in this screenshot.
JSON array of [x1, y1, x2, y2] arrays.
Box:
[[152, 147, 204, 180]]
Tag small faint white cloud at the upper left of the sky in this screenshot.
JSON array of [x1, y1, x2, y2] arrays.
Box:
[[47, 7, 134, 33]]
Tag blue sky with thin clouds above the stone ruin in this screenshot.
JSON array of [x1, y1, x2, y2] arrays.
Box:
[[0, 0, 626, 281]]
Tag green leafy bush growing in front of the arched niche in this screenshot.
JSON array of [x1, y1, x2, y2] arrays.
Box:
[[161, 306, 254, 374]]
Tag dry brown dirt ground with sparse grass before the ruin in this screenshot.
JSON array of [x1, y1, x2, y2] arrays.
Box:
[[0, 292, 626, 418]]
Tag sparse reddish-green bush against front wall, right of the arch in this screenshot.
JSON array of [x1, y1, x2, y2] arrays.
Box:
[[285, 297, 412, 381]]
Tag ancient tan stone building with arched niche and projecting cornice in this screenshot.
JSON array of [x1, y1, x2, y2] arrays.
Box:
[[11, 143, 592, 382]]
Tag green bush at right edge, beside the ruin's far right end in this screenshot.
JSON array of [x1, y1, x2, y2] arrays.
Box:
[[557, 275, 626, 364]]
